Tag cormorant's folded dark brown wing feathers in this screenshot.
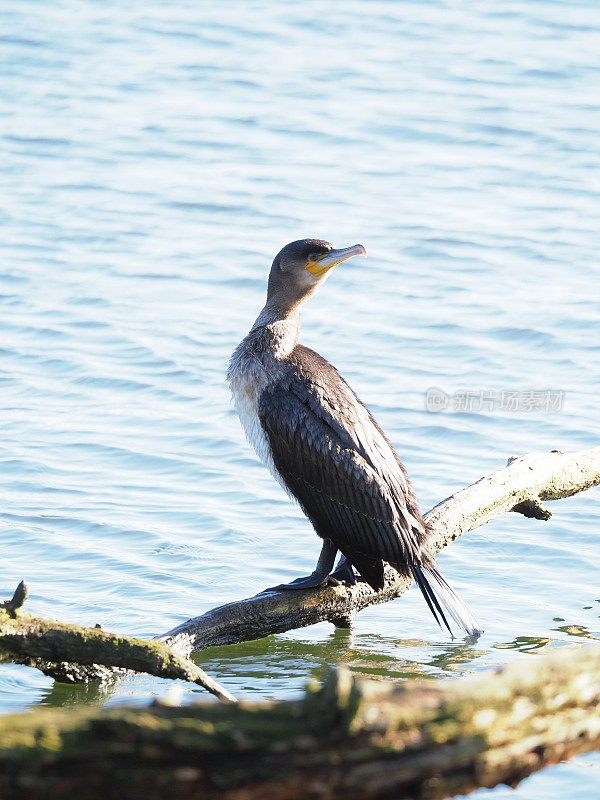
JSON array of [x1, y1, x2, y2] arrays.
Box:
[[258, 347, 425, 588]]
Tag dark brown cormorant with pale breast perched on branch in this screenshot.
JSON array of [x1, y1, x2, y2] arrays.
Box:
[[227, 239, 481, 636]]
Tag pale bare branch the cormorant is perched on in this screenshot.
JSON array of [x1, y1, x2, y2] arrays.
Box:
[[158, 447, 600, 655]]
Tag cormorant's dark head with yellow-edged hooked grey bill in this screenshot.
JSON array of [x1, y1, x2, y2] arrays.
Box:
[[267, 239, 367, 310]]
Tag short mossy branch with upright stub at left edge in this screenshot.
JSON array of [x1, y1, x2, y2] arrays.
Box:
[[0, 582, 235, 701]]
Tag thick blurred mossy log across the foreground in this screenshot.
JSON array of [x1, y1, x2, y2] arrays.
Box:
[[0, 646, 600, 800]]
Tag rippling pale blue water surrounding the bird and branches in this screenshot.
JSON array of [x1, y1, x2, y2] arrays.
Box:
[[0, 0, 600, 800]]
